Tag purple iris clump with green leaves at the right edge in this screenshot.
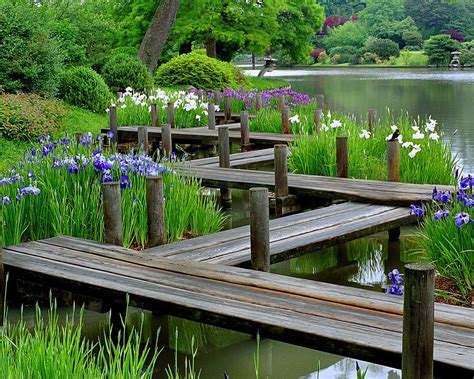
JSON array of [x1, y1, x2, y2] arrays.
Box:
[[417, 175, 474, 296]]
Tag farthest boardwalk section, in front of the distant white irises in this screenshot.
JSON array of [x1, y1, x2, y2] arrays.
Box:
[[102, 124, 295, 146]]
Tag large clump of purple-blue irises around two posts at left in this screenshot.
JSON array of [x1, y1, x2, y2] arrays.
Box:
[[0, 133, 224, 248]]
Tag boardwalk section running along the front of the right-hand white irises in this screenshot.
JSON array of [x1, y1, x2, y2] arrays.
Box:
[[175, 164, 453, 206]]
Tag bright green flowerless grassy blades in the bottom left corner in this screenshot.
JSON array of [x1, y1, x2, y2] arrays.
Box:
[[0, 303, 159, 379]]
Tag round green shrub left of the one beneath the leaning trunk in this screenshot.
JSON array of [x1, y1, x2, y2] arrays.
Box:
[[59, 67, 112, 113]]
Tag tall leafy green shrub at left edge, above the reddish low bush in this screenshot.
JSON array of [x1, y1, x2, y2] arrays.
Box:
[[0, 1, 63, 95]]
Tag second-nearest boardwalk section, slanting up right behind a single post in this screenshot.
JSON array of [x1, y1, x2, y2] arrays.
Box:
[[145, 202, 415, 266]]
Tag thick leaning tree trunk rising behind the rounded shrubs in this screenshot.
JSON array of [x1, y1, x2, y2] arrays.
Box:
[[138, 0, 179, 71]]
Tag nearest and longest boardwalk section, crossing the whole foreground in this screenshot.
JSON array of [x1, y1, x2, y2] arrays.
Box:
[[3, 237, 474, 378]]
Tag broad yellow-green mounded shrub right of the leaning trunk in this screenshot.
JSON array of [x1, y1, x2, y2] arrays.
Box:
[[156, 51, 244, 91]]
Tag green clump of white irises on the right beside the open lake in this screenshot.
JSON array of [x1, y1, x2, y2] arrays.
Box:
[[286, 111, 457, 184]]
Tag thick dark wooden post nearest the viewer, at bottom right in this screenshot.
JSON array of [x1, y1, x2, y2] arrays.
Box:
[[402, 263, 434, 379]]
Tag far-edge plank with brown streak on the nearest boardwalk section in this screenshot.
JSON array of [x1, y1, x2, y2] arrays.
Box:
[[39, 238, 474, 329]]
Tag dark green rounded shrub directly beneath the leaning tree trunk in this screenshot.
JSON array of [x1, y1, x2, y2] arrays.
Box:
[[102, 53, 153, 93]]
